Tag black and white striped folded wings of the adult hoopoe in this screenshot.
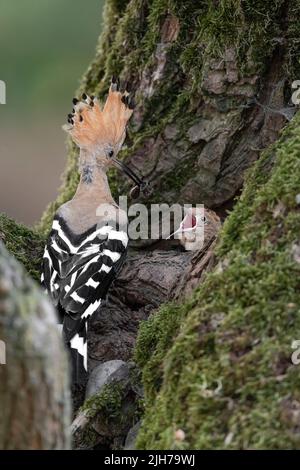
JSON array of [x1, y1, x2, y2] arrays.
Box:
[[42, 218, 128, 360]]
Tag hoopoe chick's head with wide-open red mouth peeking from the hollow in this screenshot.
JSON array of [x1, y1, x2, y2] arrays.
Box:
[[174, 207, 221, 251]]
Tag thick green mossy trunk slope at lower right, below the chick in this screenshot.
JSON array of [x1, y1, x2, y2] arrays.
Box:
[[135, 113, 300, 449]]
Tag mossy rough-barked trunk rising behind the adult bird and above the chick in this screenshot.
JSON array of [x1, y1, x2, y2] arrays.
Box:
[[41, 0, 300, 235]]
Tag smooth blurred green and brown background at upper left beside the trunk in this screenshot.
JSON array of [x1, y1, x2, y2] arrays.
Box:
[[0, 0, 104, 224]]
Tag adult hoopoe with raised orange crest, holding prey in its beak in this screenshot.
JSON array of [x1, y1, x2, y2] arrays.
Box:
[[41, 78, 144, 384]]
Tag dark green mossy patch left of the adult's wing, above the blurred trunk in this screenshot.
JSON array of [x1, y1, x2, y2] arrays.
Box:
[[0, 214, 45, 281]]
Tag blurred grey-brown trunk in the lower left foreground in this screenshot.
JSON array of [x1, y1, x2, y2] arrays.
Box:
[[0, 242, 70, 449]]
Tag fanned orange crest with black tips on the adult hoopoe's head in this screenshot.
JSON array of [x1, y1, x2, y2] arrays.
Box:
[[63, 78, 134, 166]]
